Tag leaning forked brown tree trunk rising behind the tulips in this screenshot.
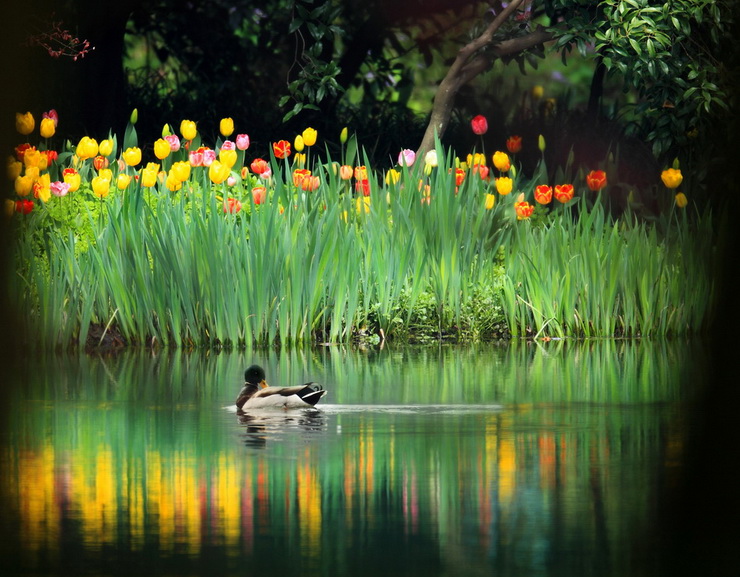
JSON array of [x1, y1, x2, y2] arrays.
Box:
[[416, 0, 552, 156]]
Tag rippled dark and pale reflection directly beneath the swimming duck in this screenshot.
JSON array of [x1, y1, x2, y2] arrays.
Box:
[[237, 409, 326, 449]]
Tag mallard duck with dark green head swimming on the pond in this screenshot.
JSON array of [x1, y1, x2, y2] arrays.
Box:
[[236, 365, 326, 411]]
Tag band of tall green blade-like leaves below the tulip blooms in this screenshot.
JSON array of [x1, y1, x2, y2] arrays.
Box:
[[5, 139, 718, 348]]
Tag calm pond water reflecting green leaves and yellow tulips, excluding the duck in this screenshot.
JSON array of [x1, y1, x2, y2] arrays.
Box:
[[0, 340, 706, 577]]
